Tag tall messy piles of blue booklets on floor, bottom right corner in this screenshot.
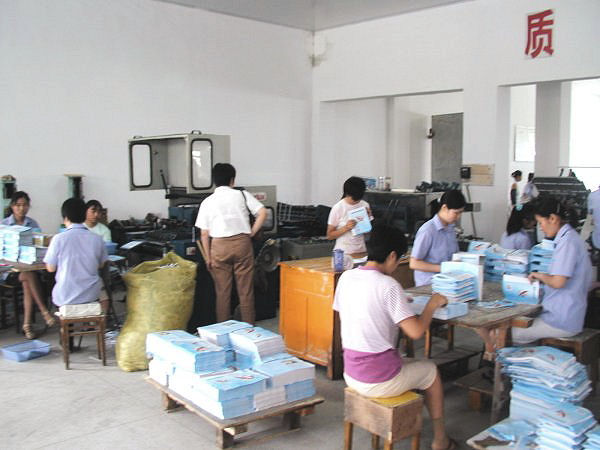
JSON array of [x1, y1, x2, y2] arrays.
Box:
[[474, 346, 596, 450]]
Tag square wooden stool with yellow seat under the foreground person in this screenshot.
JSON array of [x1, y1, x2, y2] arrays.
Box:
[[344, 388, 423, 450]]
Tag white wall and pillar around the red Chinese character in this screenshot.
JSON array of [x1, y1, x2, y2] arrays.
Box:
[[311, 0, 600, 239]]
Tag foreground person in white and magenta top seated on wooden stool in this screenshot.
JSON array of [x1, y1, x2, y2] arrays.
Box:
[[333, 224, 456, 449]]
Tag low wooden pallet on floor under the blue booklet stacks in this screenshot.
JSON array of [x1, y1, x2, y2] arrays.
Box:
[[145, 377, 325, 448]]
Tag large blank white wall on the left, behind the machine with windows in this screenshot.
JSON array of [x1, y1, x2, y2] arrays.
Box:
[[0, 0, 312, 232]]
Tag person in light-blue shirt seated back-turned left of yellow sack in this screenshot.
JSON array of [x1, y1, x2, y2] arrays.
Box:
[[44, 198, 108, 312]]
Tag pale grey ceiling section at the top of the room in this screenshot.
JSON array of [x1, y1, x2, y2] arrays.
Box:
[[158, 0, 473, 31]]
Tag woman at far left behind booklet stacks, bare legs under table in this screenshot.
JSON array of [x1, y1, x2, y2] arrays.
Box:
[[2, 191, 55, 339]]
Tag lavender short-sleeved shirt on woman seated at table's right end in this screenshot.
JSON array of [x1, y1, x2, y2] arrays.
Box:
[[540, 224, 592, 333]]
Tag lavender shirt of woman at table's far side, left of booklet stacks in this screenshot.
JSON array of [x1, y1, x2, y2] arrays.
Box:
[[410, 214, 458, 287]]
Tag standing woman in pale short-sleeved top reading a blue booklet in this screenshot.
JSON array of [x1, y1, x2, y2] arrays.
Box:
[[327, 177, 373, 254]]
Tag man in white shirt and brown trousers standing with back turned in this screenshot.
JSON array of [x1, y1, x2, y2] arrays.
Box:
[[196, 163, 267, 324]]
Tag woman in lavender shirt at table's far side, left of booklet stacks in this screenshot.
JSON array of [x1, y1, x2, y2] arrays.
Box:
[[409, 190, 466, 286]]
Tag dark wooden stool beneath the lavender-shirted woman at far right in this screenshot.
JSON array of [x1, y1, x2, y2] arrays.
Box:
[[540, 328, 600, 395]]
